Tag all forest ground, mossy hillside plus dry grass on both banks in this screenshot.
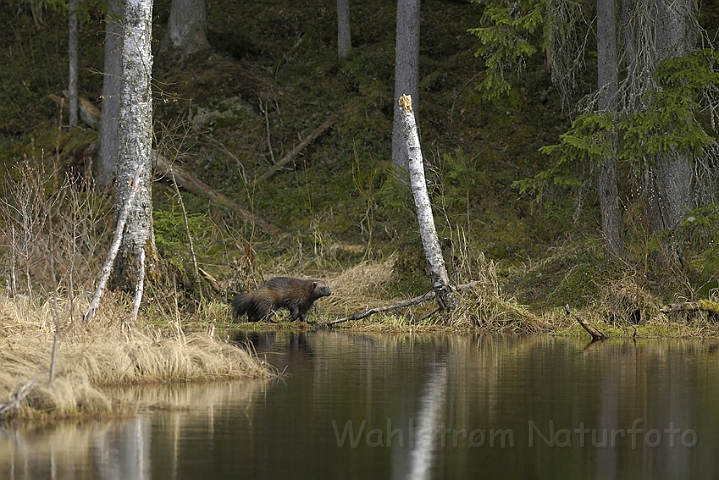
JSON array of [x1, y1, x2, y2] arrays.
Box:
[[5, 0, 719, 426]]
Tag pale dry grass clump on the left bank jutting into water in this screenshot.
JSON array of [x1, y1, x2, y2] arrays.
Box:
[[0, 298, 276, 420]]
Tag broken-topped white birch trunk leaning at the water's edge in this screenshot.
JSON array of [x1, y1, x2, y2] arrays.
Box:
[[398, 95, 457, 312]]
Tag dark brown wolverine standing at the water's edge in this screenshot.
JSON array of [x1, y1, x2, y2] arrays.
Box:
[[232, 277, 330, 322]]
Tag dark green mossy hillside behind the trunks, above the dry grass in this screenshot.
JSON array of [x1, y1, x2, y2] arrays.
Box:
[[0, 0, 719, 322]]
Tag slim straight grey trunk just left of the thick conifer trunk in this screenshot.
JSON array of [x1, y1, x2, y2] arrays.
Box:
[[597, 0, 625, 259]]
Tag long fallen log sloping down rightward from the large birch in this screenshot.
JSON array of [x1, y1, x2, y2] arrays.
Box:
[[155, 154, 282, 235]]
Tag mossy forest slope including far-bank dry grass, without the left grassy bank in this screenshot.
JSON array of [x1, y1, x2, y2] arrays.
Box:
[[0, 0, 719, 344]]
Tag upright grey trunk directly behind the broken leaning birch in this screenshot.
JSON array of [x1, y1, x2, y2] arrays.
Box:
[[392, 0, 420, 169]]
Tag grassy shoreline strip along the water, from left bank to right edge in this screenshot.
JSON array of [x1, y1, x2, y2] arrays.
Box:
[[0, 299, 719, 424]]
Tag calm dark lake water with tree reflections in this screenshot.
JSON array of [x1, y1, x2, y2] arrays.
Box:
[[0, 332, 719, 480]]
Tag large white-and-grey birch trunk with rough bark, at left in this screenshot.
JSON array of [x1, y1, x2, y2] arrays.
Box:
[[113, 0, 155, 292]]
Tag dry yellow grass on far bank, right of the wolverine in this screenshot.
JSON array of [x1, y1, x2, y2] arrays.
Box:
[[318, 253, 719, 338]]
